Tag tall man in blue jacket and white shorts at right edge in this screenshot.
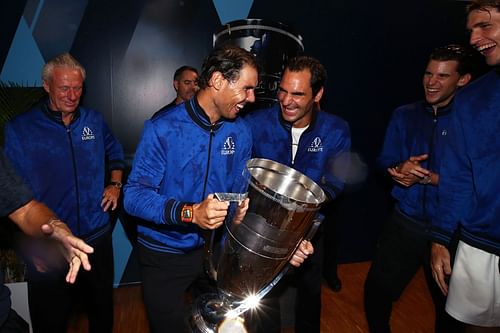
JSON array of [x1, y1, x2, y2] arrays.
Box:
[[432, 0, 500, 332]]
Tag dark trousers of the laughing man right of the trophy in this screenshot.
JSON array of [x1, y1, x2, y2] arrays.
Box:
[[246, 227, 324, 333]]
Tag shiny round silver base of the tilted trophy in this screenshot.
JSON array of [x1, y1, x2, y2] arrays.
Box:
[[189, 293, 247, 333]]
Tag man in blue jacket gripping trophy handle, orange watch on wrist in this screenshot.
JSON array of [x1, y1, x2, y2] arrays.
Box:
[[125, 47, 258, 332]]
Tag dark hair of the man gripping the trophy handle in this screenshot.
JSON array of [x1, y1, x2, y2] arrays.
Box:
[[198, 44, 259, 89]]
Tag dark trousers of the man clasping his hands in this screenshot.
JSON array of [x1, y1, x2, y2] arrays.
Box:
[[364, 212, 461, 333]]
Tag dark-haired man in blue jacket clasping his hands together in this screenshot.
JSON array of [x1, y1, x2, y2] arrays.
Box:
[[365, 45, 471, 333]]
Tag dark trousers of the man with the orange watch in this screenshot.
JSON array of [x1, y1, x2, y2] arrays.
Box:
[[139, 245, 211, 333]]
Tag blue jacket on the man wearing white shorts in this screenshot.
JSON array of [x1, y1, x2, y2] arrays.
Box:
[[432, 70, 500, 255]]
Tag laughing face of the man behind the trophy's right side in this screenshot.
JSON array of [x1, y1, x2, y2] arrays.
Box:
[[278, 69, 323, 127]]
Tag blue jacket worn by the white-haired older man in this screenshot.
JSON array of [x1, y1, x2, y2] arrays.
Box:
[[5, 101, 125, 241]]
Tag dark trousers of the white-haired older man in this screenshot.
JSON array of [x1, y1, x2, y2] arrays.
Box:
[[27, 233, 114, 333]]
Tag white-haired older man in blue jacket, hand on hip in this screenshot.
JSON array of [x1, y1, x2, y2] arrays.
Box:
[[5, 53, 124, 332]]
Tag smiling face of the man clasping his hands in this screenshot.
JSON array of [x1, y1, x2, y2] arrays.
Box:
[[422, 60, 468, 109]]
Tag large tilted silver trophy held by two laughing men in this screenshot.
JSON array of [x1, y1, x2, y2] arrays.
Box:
[[190, 158, 326, 333]]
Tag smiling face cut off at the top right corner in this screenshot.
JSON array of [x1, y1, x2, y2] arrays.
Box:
[[467, 7, 500, 66]]
